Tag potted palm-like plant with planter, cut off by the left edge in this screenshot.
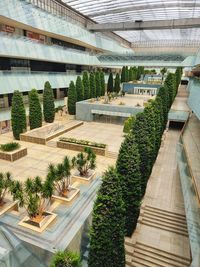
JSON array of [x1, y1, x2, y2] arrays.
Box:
[[0, 172, 17, 215]]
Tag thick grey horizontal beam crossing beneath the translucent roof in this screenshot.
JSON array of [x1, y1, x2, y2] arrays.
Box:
[[87, 18, 200, 32]]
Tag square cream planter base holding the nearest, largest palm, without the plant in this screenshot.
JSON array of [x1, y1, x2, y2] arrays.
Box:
[[18, 211, 57, 233]]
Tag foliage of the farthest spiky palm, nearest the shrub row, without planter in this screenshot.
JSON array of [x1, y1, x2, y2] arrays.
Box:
[[72, 147, 96, 176]]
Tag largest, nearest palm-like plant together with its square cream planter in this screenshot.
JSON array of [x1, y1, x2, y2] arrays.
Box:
[[10, 176, 56, 232]]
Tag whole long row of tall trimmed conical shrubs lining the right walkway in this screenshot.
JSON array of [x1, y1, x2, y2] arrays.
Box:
[[88, 68, 182, 267]]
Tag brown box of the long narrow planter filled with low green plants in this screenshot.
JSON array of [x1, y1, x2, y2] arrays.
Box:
[[57, 141, 106, 156]]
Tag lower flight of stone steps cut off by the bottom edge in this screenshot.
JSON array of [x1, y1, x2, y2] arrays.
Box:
[[125, 242, 190, 267]]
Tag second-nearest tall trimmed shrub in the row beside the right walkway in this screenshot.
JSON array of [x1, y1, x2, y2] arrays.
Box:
[[116, 134, 141, 236]]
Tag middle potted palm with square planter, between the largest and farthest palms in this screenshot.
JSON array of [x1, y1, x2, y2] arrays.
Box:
[[47, 156, 80, 202]]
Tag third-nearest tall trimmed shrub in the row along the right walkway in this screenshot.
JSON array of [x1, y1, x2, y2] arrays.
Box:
[[133, 112, 151, 195]]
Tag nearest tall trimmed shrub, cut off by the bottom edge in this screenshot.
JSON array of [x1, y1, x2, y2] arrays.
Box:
[[88, 168, 125, 267]]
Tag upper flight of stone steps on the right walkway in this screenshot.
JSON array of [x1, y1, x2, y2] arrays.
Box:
[[138, 206, 188, 237]]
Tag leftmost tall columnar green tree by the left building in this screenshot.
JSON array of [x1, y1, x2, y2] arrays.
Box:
[[11, 91, 26, 140]]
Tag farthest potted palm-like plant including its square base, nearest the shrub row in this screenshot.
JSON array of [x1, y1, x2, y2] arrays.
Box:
[[72, 147, 96, 184]]
